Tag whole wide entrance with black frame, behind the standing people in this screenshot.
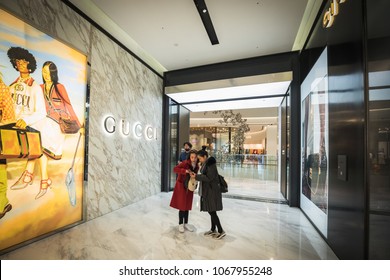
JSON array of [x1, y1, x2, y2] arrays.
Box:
[[162, 68, 296, 205]]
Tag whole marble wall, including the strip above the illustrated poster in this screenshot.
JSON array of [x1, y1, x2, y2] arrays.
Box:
[[0, 0, 163, 220]]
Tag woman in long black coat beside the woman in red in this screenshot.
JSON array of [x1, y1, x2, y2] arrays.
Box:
[[191, 150, 226, 239]]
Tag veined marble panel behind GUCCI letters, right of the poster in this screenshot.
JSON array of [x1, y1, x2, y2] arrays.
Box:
[[87, 27, 162, 219]]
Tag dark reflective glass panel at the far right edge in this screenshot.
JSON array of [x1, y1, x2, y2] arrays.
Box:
[[366, 0, 390, 259]]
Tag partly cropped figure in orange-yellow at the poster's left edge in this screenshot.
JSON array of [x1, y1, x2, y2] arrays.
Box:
[[0, 70, 15, 219]]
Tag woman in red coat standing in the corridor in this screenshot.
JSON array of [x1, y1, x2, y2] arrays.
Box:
[[170, 150, 199, 233]]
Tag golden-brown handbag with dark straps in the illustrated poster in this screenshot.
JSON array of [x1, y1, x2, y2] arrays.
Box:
[[0, 123, 42, 159]]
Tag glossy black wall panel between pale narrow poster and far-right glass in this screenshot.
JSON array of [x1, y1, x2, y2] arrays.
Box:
[[300, 0, 366, 259]]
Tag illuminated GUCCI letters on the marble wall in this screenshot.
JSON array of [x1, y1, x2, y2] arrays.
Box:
[[103, 116, 157, 140]]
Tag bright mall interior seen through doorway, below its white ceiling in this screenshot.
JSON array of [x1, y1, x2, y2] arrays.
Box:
[[189, 107, 286, 203]]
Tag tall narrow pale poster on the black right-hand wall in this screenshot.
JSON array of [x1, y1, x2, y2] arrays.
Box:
[[301, 48, 329, 236]]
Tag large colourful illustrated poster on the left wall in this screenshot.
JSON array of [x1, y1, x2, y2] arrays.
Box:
[[0, 9, 87, 253]]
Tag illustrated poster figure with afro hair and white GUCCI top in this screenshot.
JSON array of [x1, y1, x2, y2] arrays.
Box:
[[7, 47, 47, 198]]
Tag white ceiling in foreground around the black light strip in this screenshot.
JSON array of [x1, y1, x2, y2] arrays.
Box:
[[70, 0, 322, 73]]
